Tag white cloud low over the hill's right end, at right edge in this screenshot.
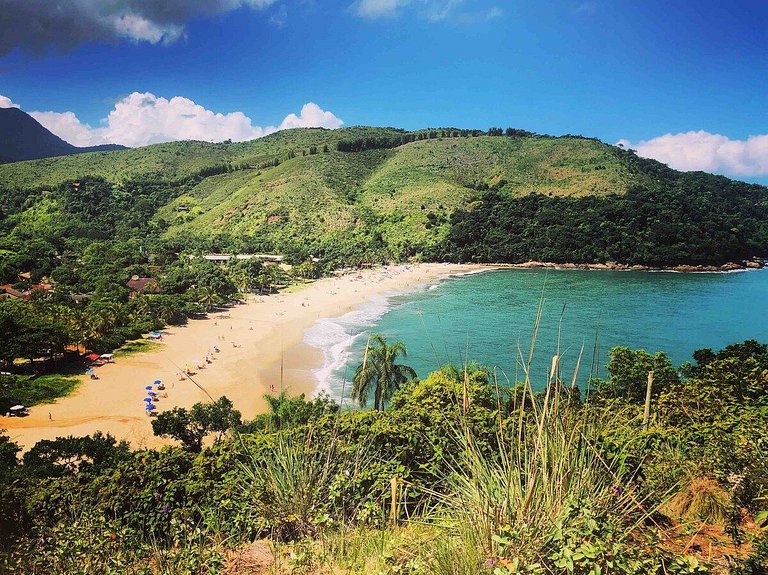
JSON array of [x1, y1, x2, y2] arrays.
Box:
[[618, 130, 768, 177]]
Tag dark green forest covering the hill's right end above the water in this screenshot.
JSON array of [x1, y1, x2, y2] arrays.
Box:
[[444, 165, 768, 267]]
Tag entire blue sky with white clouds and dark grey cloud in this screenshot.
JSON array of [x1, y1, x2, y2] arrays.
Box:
[[0, 0, 768, 184]]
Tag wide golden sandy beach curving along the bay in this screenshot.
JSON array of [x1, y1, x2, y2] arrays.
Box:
[[0, 264, 481, 450]]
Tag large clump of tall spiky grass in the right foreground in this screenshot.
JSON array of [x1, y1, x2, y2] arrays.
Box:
[[428, 356, 648, 575]]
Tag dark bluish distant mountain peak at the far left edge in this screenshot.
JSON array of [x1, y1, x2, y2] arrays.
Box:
[[0, 108, 126, 163]]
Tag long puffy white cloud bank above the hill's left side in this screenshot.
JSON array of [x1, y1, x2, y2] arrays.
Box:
[[30, 92, 344, 147]]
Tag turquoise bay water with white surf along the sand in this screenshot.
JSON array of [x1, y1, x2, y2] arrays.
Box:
[[305, 270, 768, 399]]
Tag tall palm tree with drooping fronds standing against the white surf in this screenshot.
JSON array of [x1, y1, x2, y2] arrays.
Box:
[[352, 333, 416, 410]]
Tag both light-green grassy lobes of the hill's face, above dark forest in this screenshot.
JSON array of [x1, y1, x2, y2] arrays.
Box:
[[158, 136, 656, 251]]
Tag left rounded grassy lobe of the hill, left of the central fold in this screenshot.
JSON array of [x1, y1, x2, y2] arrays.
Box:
[[158, 150, 391, 250]]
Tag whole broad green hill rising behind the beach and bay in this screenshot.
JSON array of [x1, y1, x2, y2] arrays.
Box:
[[0, 127, 768, 279]]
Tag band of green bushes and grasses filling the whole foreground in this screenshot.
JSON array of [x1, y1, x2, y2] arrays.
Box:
[[0, 341, 768, 575]]
